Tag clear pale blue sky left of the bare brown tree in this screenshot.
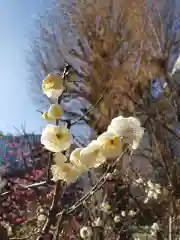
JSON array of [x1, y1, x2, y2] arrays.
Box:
[[0, 0, 46, 133]]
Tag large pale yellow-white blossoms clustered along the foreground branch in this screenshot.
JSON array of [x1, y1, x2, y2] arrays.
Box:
[[41, 73, 144, 184]]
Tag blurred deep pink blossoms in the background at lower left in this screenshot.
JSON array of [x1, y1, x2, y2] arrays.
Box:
[[0, 169, 45, 225]]
